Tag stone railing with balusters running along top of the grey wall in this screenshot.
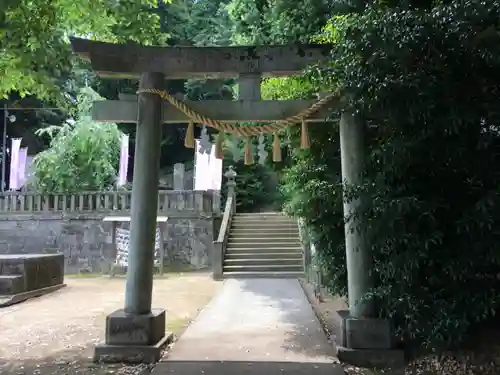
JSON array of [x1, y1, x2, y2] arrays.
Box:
[[0, 190, 220, 215]]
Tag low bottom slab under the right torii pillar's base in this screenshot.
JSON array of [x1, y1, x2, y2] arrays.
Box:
[[336, 346, 406, 370]]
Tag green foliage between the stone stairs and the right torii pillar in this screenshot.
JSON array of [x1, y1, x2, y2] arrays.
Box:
[[281, 130, 347, 296]]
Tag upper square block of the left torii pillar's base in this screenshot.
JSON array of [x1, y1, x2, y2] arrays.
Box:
[[106, 309, 166, 346]]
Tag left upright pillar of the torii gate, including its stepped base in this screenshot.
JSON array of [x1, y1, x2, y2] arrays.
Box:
[[94, 73, 171, 362]]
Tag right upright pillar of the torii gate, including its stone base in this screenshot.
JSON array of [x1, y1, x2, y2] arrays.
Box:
[[336, 111, 405, 369]]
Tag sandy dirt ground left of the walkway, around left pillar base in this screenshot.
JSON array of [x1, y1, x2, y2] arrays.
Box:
[[0, 273, 221, 375]]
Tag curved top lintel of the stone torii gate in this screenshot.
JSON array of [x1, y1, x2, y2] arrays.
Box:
[[71, 38, 331, 79]]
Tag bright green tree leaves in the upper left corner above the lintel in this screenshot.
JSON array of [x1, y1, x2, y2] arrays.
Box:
[[0, 0, 169, 102]]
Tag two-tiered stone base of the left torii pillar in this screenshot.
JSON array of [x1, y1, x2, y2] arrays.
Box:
[[93, 309, 173, 363]]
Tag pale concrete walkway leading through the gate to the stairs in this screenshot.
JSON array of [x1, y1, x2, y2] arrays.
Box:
[[152, 279, 344, 375]]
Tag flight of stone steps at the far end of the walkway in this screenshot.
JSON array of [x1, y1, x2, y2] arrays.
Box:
[[223, 212, 304, 278]]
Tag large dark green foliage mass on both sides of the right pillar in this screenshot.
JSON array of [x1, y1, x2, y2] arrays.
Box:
[[283, 0, 500, 348]]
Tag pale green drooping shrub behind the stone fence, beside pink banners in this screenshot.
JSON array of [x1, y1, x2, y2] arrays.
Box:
[[31, 89, 122, 193]]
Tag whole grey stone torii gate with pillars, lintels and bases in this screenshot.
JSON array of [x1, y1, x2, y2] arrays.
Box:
[[71, 38, 398, 368]]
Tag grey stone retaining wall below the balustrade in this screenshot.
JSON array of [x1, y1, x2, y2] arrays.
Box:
[[0, 213, 220, 273]]
